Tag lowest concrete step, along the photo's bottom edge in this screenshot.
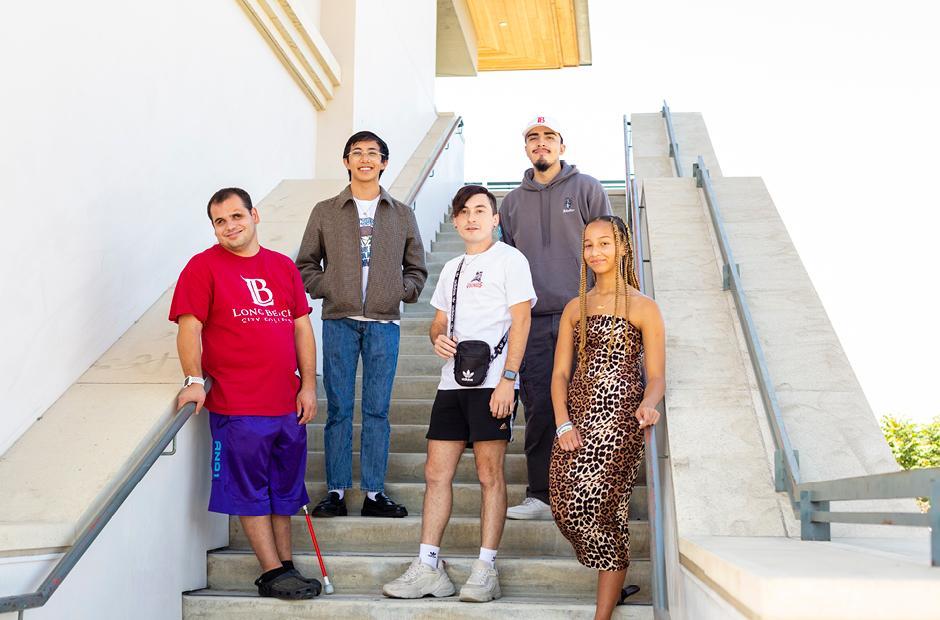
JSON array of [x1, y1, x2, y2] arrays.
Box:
[[183, 586, 653, 620]]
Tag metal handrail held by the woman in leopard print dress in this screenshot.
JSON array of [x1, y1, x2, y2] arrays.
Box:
[[623, 116, 669, 620]]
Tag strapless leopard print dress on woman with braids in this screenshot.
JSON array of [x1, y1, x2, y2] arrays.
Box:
[[549, 315, 644, 571]]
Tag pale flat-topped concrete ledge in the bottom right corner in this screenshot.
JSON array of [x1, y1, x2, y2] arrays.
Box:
[[679, 536, 940, 620]]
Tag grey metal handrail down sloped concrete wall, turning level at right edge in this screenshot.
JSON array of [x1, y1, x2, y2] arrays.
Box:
[[692, 156, 940, 566]]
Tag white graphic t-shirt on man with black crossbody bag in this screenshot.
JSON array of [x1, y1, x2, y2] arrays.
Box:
[[431, 241, 538, 390]]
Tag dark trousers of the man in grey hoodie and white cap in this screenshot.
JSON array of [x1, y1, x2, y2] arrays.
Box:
[[519, 313, 561, 504]]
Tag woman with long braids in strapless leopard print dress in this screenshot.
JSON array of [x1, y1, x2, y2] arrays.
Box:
[[549, 216, 665, 618]]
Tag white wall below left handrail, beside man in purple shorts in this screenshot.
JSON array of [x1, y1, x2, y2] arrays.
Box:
[[0, 415, 228, 620]]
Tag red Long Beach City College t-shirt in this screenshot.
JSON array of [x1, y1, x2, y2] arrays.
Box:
[[170, 245, 310, 416]]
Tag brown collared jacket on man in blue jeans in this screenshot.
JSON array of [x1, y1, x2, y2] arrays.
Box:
[[297, 185, 428, 321]]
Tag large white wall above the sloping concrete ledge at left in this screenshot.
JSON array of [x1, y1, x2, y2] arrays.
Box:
[[0, 0, 320, 454]]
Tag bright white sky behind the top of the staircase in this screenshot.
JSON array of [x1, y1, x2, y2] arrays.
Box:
[[437, 0, 940, 421]]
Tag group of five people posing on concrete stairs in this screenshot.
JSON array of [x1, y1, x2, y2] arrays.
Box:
[[170, 116, 665, 618]]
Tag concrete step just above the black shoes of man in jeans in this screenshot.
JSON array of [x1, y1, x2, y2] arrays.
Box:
[[306, 450, 528, 484]]
